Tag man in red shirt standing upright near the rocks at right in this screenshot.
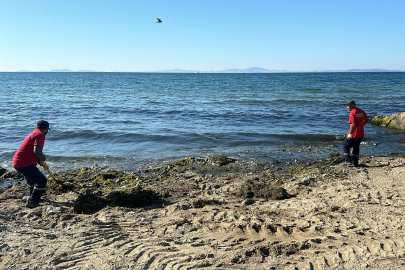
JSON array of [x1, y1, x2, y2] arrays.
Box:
[[343, 101, 369, 167]]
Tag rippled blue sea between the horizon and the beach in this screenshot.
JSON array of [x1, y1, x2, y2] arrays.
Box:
[[0, 72, 405, 174]]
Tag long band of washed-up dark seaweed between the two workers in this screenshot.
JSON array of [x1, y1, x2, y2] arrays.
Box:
[[3, 153, 343, 214]]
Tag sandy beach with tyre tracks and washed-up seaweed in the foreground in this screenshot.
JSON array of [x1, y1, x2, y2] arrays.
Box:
[[0, 155, 405, 270]]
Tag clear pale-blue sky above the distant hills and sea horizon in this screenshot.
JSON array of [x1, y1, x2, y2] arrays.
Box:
[[0, 0, 405, 71]]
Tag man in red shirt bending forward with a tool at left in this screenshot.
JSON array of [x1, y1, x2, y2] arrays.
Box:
[[13, 120, 50, 208]]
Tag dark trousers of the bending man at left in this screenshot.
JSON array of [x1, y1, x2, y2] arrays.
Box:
[[15, 165, 47, 203]]
